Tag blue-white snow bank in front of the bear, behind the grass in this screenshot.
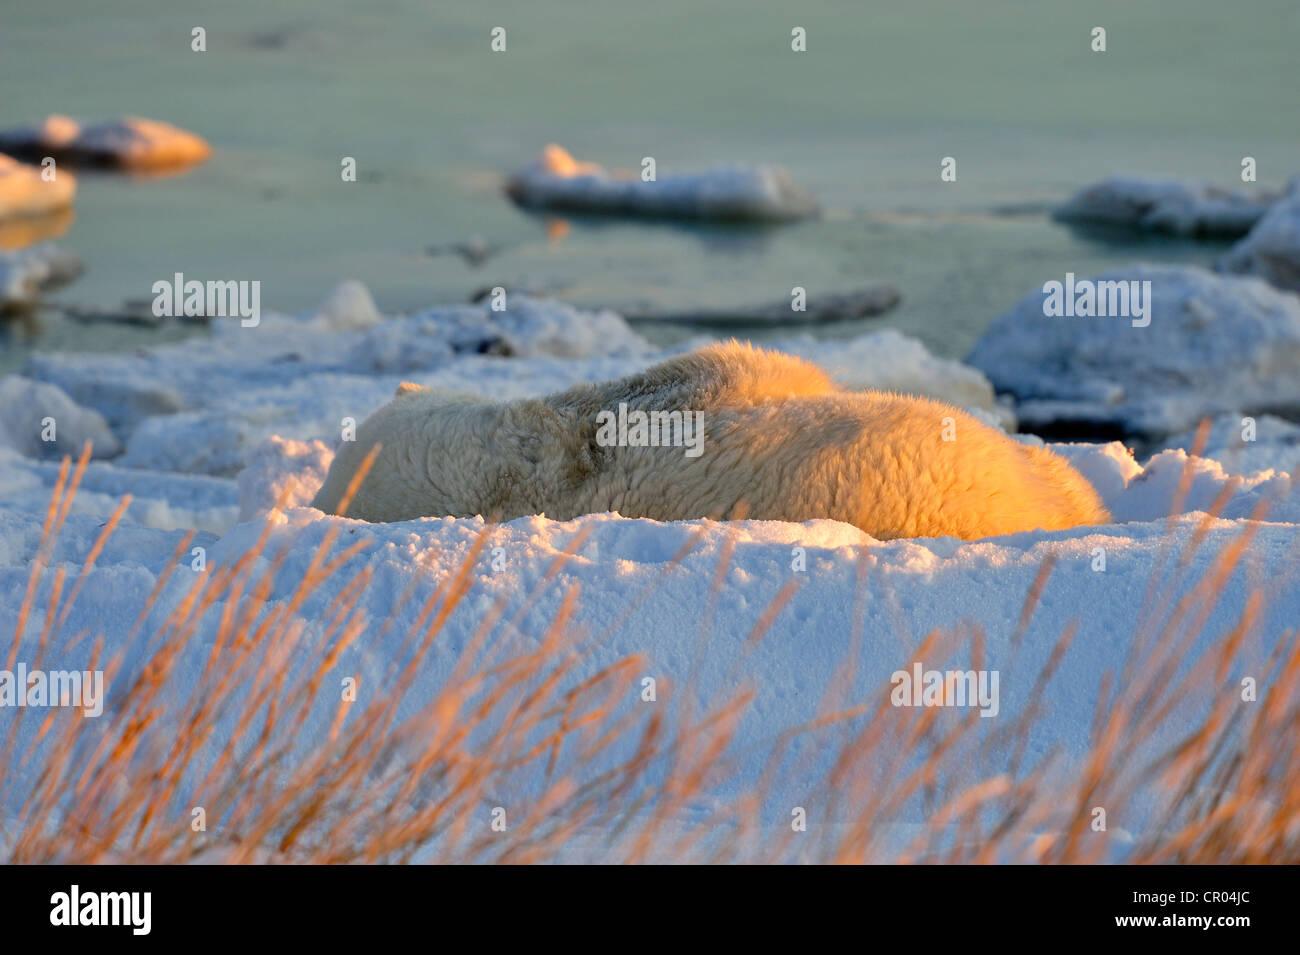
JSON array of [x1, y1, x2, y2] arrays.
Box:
[[0, 465, 1300, 825]]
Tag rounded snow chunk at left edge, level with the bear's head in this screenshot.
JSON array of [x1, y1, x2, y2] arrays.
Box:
[[0, 374, 122, 457]]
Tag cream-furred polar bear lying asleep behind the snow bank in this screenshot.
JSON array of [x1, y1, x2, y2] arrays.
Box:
[[312, 342, 1109, 539]]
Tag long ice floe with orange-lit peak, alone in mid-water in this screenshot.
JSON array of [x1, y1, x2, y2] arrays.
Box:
[[506, 144, 818, 222]]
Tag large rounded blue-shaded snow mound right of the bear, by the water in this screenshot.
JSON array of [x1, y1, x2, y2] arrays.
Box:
[[967, 265, 1300, 437]]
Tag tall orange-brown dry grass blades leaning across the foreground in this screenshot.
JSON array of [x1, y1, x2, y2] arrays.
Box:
[[0, 441, 1300, 863]]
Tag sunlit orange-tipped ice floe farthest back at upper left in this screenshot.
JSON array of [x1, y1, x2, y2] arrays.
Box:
[[0, 114, 212, 170]]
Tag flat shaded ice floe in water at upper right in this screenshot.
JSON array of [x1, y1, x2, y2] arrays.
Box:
[[1052, 175, 1277, 236]]
